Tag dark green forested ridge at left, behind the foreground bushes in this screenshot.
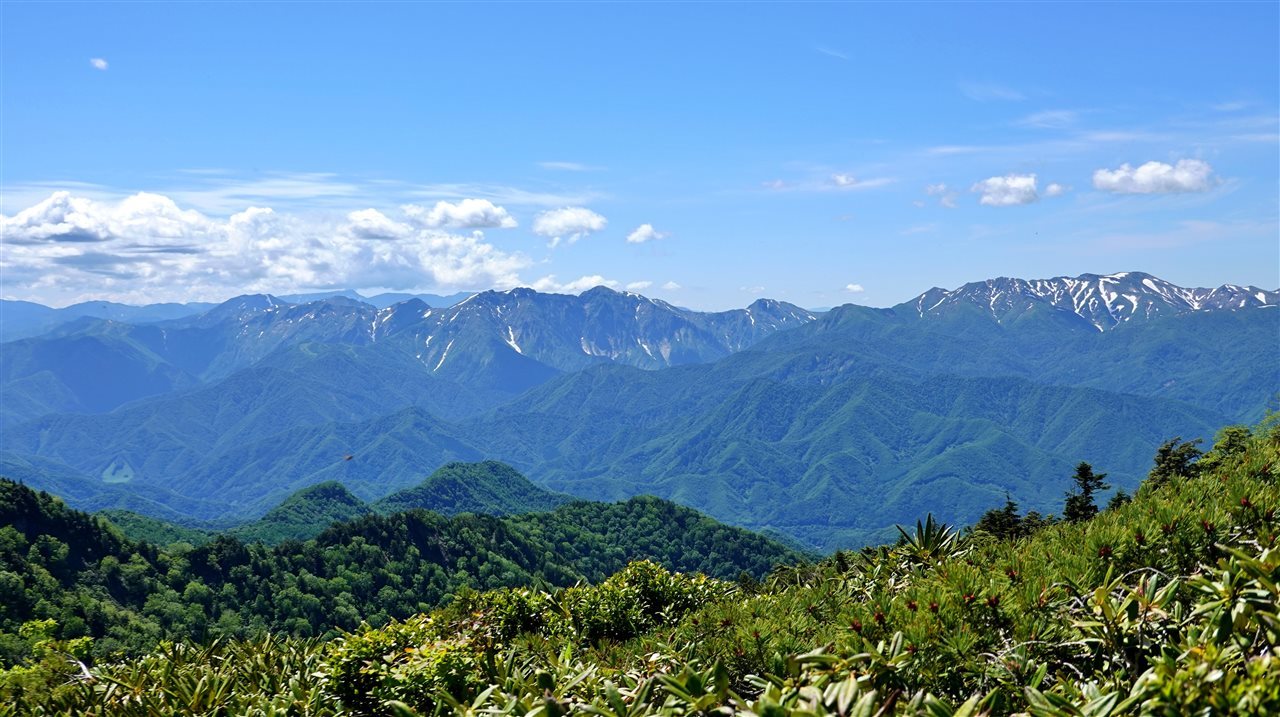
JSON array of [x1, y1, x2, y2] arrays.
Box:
[[0, 480, 801, 661]]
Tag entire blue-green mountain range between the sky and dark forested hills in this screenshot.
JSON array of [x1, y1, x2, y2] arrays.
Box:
[[0, 273, 1280, 548]]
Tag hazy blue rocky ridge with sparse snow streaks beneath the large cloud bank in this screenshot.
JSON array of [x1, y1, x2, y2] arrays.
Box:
[[0, 287, 814, 425]]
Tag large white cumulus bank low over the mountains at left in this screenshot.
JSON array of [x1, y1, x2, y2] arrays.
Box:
[[0, 192, 529, 303]]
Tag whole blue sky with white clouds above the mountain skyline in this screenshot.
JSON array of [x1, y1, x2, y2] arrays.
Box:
[[0, 3, 1280, 309]]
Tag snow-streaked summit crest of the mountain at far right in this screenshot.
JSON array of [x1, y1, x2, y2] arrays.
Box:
[[909, 271, 1280, 332]]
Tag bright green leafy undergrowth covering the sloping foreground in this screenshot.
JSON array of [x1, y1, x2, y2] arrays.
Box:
[[0, 426, 1280, 717]]
